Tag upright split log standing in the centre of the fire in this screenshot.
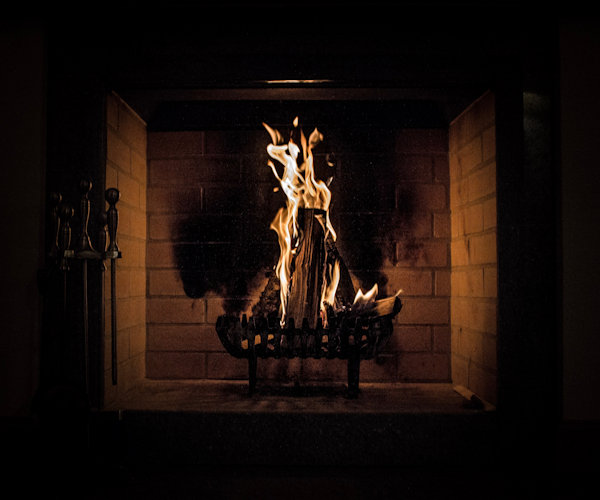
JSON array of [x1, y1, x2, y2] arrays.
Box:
[[286, 208, 326, 328]]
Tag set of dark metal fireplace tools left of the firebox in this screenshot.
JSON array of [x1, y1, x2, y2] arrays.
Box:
[[50, 180, 121, 394]]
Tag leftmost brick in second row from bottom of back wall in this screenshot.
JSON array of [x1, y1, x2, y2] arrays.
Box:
[[147, 324, 225, 352]]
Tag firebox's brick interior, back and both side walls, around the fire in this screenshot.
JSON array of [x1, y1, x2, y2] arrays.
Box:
[[104, 89, 497, 407]]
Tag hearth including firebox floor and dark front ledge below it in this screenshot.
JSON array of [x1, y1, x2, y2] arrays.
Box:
[[92, 380, 497, 466]]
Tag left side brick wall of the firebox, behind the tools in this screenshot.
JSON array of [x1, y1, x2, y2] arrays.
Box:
[[104, 93, 147, 403]]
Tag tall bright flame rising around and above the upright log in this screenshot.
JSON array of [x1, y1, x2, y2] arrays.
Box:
[[263, 117, 340, 325]]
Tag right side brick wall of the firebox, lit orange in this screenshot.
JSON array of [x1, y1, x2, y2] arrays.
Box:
[[449, 92, 498, 403]]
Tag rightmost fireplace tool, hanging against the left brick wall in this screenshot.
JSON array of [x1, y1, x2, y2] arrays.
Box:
[[104, 188, 121, 385]]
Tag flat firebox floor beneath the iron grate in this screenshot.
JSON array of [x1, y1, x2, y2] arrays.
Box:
[[106, 379, 488, 415]]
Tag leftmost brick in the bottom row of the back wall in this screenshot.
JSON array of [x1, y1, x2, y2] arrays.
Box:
[[146, 351, 206, 379]]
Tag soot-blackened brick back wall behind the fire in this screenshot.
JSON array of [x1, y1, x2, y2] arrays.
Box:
[[146, 128, 450, 381]]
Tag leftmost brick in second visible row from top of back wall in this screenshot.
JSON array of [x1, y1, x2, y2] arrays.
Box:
[[148, 156, 241, 186]]
